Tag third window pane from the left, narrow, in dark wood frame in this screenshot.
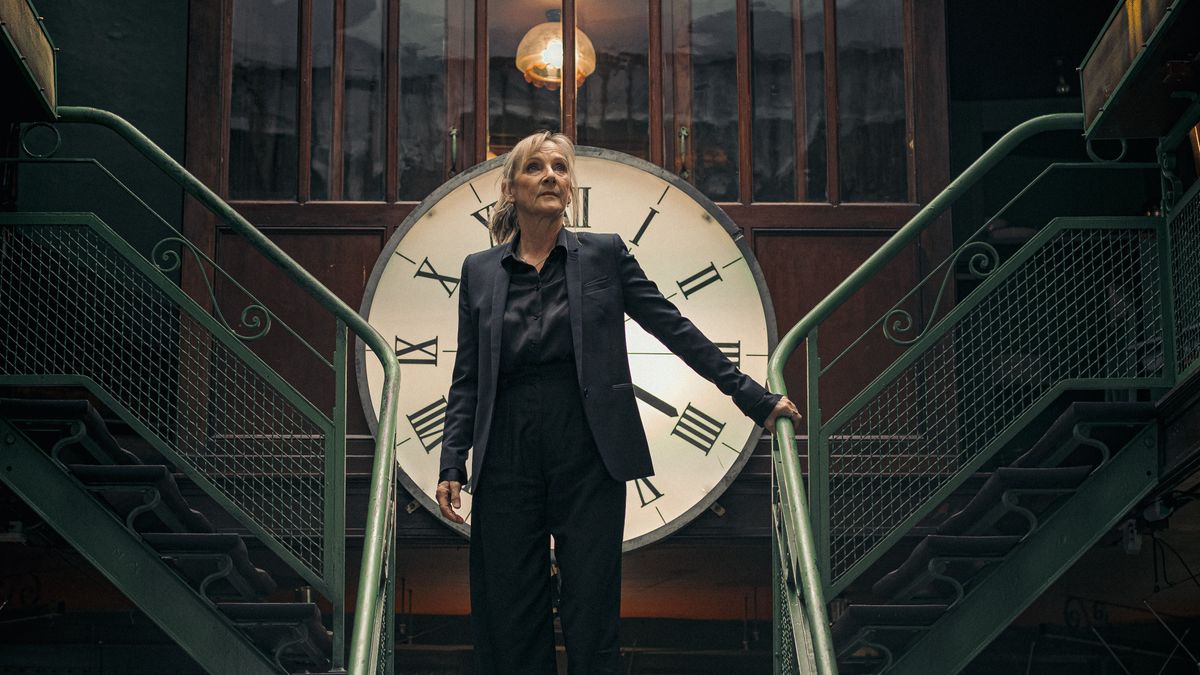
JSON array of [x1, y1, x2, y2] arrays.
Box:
[[342, 0, 388, 199]]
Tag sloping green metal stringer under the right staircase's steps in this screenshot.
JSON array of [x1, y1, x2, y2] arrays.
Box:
[[887, 424, 1159, 675]]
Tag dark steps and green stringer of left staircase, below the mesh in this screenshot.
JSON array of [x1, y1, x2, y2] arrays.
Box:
[[0, 400, 331, 674]]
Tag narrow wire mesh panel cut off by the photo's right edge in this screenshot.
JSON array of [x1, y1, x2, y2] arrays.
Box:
[[1170, 183, 1200, 372]]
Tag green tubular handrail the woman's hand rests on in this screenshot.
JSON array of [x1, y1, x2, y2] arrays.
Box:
[[767, 113, 1084, 673]]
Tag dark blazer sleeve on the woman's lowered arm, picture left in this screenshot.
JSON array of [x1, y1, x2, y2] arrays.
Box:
[[438, 256, 479, 483]]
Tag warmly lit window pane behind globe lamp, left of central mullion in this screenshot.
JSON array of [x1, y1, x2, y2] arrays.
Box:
[[487, 2, 560, 157]]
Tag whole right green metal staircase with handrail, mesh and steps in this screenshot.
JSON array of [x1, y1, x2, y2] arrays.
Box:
[[770, 106, 1200, 674]]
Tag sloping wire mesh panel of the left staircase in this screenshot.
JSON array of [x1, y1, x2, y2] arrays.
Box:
[[0, 226, 328, 578]]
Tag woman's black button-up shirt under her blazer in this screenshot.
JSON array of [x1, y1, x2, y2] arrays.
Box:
[[439, 229, 575, 483]]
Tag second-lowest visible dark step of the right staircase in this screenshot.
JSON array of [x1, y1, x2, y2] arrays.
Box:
[[871, 534, 1021, 595]]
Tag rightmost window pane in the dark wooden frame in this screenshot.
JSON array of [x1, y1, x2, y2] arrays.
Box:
[[838, 0, 908, 202]]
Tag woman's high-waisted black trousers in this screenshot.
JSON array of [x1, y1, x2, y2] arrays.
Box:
[[470, 365, 625, 675]]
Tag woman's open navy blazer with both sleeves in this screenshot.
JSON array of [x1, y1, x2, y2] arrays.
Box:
[[440, 229, 780, 489]]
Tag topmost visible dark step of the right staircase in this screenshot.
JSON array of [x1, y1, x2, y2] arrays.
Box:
[[1012, 402, 1154, 468]]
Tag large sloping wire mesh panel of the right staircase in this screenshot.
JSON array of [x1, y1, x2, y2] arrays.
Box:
[[827, 227, 1163, 584]]
